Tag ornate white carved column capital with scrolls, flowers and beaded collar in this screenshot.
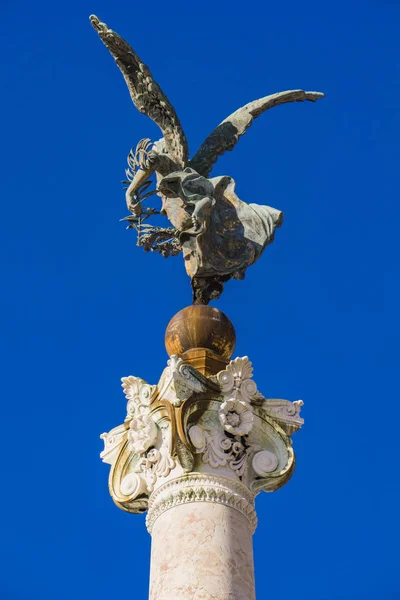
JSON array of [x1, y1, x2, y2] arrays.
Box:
[[101, 355, 303, 531]]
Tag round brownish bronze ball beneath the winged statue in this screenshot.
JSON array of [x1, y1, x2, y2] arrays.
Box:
[[165, 305, 236, 360]]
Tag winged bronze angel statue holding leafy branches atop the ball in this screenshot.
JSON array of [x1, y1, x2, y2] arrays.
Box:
[[90, 15, 324, 304]]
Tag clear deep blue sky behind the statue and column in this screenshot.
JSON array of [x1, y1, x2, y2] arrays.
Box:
[[0, 0, 400, 600]]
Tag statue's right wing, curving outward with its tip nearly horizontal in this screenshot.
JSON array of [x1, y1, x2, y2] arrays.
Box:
[[189, 90, 325, 177]]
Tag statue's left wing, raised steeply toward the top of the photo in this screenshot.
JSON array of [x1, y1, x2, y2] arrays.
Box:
[[90, 15, 188, 166]]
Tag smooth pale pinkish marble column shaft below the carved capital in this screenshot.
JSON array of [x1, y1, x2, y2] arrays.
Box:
[[149, 478, 255, 600]]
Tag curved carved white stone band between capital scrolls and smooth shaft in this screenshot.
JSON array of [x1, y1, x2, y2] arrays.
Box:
[[146, 473, 257, 533]]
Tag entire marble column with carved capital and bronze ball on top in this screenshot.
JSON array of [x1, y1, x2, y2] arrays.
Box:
[[101, 306, 303, 600]]
